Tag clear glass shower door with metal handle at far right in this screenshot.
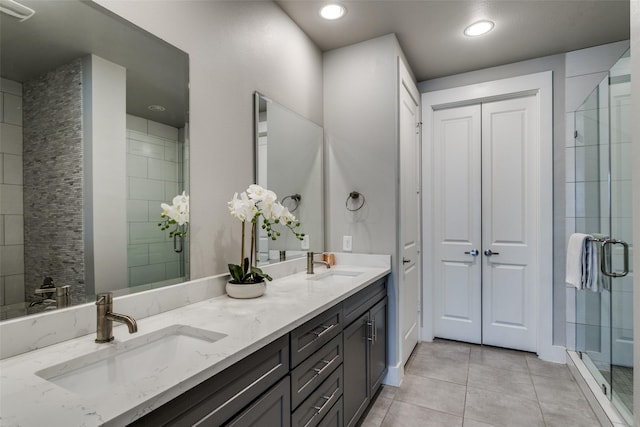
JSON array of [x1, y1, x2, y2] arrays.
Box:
[[575, 48, 633, 424]]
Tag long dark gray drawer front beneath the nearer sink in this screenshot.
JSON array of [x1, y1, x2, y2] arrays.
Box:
[[132, 336, 289, 427]]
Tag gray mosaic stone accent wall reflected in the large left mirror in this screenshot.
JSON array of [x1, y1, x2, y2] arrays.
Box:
[[21, 59, 85, 304]]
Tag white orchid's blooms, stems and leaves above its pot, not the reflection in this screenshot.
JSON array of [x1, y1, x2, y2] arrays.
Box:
[[227, 184, 304, 284]]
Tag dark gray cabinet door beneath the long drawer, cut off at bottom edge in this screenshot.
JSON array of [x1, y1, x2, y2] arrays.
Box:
[[221, 376, 291, 427]]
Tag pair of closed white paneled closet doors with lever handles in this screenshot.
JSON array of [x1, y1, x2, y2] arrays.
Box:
[[433, 96, 540, 352]]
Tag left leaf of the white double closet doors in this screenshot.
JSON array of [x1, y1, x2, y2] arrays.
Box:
[[432, 105, 482, 343]]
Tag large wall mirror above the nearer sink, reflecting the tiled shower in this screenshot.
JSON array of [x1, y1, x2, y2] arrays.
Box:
[[0, 0, 189, 319]]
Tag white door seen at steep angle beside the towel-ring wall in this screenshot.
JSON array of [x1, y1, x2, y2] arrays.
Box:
[[399, 61, 421, 363]]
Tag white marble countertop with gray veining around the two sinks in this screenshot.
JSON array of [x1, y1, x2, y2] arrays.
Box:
[[0, 265, 391, 426]]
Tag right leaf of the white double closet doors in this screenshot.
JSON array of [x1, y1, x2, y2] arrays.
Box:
[[482, 96, 536, 352]]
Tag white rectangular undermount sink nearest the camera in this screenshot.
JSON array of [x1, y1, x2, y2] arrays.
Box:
[[36, 325, 226, 397]]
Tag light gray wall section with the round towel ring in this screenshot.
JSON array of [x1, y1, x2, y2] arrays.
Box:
[[324, 34, 402, 372]]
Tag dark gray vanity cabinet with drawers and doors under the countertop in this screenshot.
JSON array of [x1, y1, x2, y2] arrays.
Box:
[[126, 278, 387, 427]]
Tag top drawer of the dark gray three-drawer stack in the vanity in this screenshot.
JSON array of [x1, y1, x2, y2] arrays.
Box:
[[291, 304, 342, 368]]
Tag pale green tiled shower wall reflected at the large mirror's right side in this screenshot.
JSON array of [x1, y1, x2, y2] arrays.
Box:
[[127, 115, 188, 286]]
